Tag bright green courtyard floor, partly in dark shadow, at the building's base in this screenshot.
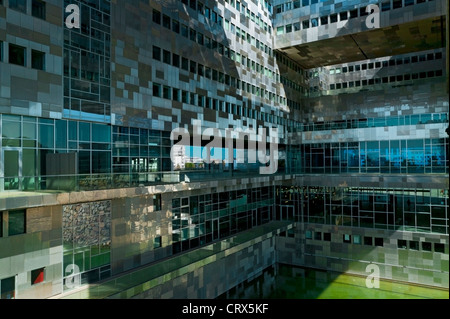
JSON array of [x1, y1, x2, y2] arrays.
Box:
[[221, 265, 449, 299]]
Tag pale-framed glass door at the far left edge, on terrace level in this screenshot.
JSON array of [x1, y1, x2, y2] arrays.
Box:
[[0, 148, 22, 190]]
